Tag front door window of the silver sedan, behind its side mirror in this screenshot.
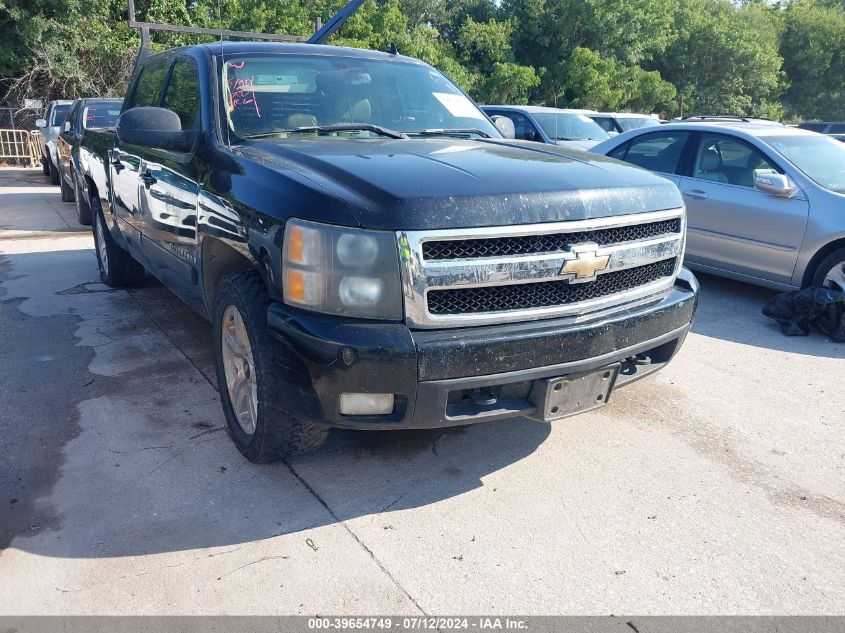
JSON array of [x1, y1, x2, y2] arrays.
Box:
[[692, 134, 779, 188]]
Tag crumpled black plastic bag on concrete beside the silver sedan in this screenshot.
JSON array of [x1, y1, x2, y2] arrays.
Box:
[[763, 288, 845, 343]]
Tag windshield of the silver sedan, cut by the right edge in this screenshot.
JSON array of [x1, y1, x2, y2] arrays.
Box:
[[763, 134, 845, 193]]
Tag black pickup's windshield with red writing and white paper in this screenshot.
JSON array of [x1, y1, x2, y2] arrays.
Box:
[[221, 54, 501, 138]]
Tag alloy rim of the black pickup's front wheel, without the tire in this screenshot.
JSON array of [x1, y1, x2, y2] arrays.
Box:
[[220, 305, 258, 435]]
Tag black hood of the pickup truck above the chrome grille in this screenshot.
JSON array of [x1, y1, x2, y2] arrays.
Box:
[[241, 137, 683, 230]]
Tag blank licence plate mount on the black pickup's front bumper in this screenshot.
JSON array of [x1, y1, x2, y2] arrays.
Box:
[[529, 363, 620, 422]]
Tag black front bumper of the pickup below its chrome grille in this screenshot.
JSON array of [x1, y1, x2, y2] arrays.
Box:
[[267, 269, 698, 429]]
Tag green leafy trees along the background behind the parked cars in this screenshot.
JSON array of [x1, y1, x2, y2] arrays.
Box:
[[0, 0, 845, 120]]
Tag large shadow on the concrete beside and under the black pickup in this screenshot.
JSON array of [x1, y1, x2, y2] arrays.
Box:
[[0, 244, 550, 558]]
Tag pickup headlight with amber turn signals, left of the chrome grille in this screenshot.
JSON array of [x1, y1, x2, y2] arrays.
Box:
[[282, 219, 402, 320]]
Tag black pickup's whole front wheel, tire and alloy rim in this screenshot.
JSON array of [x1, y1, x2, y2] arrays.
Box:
[[213, 271, 328, 463]]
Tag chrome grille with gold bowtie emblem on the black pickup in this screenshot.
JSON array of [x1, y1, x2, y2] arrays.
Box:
[[397, 209, 685, 328]]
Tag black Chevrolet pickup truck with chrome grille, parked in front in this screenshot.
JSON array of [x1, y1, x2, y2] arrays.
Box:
[[81, 42, 697, 461]]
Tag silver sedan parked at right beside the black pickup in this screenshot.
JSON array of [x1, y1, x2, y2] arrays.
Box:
[[591, 119, 845, 291]]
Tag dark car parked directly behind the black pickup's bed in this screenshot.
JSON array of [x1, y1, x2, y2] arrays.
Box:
[[56, 99, 123, 224]]
